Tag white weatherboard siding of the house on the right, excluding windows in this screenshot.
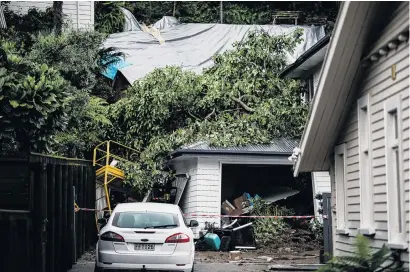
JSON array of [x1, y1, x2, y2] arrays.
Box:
[[331, 2, 410, 263]]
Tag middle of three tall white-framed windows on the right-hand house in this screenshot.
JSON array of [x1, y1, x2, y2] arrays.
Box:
[[357, 95, 375, 235]]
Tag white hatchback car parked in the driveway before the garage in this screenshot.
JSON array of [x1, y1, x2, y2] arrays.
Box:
[[95, 203, 198, 272]]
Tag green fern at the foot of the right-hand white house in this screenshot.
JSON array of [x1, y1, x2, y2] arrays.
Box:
[[318, 235, 408, 272]]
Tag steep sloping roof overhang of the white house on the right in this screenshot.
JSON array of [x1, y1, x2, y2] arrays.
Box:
[[294, 2, 379, 176]]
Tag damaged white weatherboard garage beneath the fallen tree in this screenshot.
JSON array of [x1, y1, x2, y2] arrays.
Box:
[[168, 139, 314, 237]]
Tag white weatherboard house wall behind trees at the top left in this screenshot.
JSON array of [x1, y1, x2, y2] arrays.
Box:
[[8, 1, 94, 29]]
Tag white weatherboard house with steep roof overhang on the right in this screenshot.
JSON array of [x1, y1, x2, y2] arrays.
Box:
[[294, 2, 410, 265]]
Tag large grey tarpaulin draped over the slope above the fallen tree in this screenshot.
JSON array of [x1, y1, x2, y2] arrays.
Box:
[[104, 13, 325, 84]]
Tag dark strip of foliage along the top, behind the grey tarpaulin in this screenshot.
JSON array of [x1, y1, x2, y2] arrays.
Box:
[[125, 1, 340, 32]]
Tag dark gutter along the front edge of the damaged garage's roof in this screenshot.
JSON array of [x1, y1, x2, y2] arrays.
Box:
[[168, 149, 292, 159]]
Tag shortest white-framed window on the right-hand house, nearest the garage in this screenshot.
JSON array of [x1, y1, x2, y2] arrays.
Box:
[[335, 144, 349, 234]]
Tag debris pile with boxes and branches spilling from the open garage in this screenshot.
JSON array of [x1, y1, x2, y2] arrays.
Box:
[[196, 191, 321, 259]]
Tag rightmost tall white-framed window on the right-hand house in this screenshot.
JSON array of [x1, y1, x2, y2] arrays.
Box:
[[384, 96, 406, 248]]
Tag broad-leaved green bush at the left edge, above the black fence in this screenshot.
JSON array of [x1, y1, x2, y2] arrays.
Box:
[[0, 41, 70, 151]]
